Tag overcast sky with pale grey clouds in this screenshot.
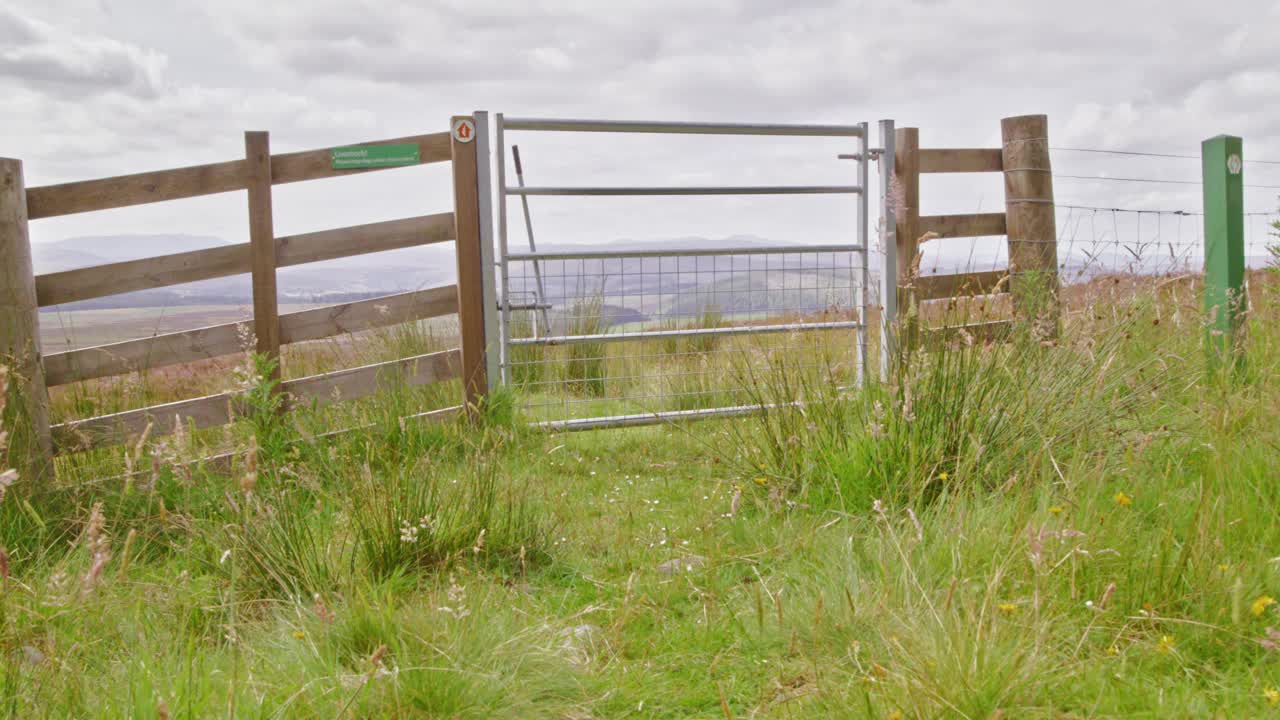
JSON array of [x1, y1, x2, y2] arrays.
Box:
[[0, 0, 1280, 269]]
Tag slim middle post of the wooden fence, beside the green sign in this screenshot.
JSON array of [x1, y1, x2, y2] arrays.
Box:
[[244, 131, 280, 380]]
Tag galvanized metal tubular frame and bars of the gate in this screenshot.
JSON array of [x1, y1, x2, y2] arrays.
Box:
[[475, 111, 897, 429]]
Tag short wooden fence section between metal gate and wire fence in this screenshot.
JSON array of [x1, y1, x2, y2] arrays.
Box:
[[893, 115, 1059, 341]]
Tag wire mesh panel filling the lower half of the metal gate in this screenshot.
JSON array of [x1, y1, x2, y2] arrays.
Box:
[[506, 246, 865, 421]]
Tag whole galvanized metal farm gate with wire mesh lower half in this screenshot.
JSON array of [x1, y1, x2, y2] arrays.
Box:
[[465, 113, 896, 429]]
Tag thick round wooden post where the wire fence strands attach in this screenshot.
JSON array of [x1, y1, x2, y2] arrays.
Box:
[[1000, 115, 1059, 337]]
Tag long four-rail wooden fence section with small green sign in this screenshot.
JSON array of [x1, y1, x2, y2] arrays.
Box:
[[0, 118, 485, 478]]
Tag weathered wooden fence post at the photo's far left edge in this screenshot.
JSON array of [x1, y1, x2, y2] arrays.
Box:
[[0, 158, 54, 482]]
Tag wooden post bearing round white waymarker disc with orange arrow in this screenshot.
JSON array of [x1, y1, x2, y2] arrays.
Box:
[[449, 115, 493, 413]]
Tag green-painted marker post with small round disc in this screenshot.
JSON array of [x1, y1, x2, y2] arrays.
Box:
[[1201, 135, 1248, 370]]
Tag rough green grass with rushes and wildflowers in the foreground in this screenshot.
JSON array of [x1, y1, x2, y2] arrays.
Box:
[[0, 266, 1280, 720]]
